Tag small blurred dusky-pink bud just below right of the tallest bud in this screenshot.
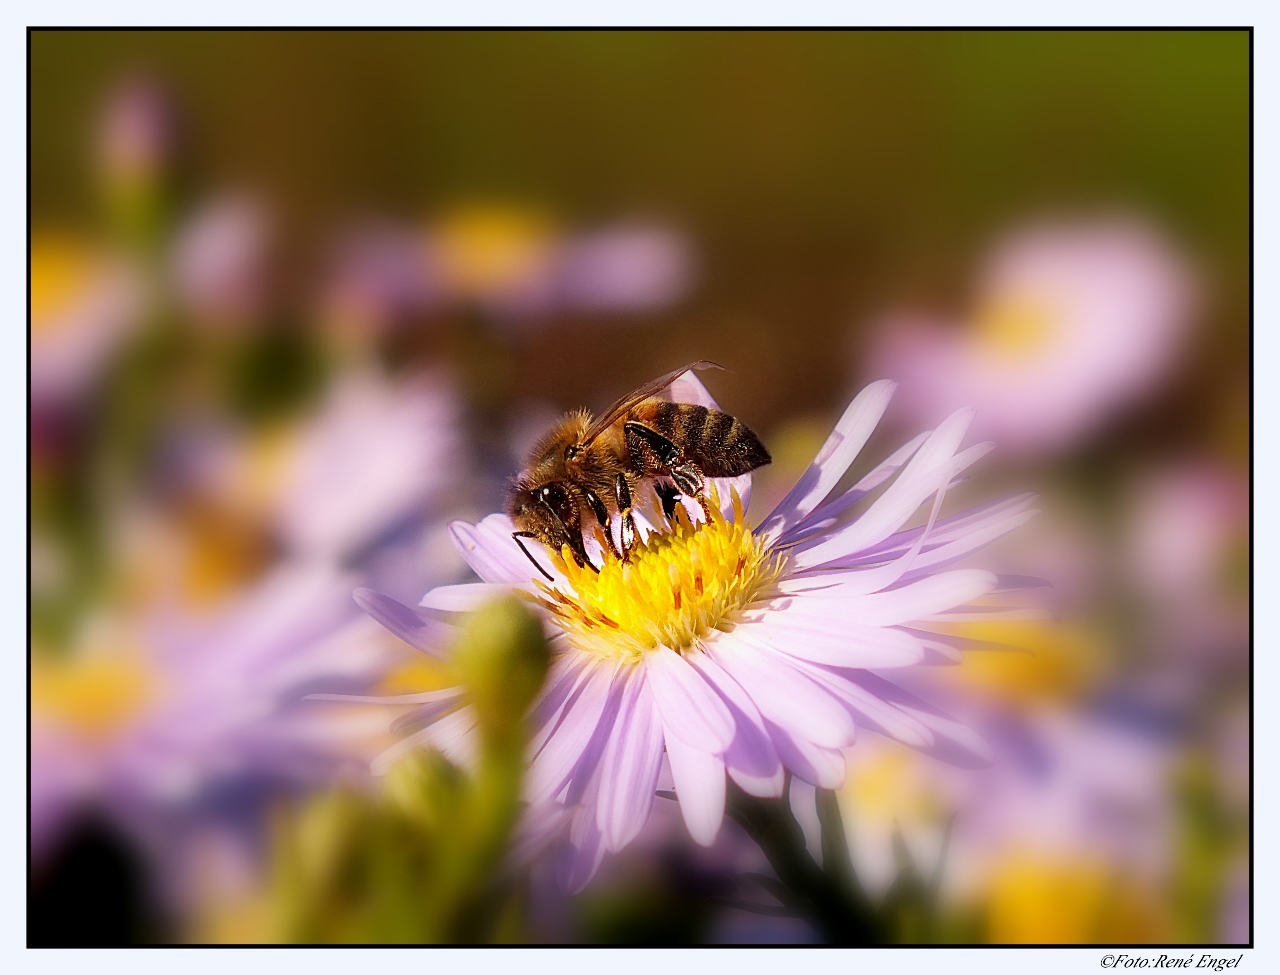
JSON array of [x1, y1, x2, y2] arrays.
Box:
[[173, 196, 270, 326]]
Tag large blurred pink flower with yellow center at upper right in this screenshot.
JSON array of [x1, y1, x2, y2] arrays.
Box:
[[870, 219, 1193, 452]]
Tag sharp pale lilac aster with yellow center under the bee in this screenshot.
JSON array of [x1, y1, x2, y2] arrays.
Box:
[[345, 374, 1033, 889]]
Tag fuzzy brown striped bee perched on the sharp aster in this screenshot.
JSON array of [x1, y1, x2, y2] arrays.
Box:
[[507, 361, 772, 578]]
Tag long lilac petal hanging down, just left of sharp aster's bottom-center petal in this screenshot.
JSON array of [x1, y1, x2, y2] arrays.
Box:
[[595, 668, 662, 852]]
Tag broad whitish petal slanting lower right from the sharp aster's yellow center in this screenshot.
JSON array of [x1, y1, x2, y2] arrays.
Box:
[[707, 623, 855, 749]]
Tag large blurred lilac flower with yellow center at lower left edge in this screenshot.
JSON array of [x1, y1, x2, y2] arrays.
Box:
[[31, 567, 399, 851]]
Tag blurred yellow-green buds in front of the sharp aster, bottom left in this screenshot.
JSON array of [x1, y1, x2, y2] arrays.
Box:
[[271, 598, 548, 943]]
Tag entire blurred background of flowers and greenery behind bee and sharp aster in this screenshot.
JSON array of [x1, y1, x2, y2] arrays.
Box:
[[29, 31, 1251, 944]]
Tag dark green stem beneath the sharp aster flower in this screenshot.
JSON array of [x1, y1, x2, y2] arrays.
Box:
[[726, 774, 883, 944]]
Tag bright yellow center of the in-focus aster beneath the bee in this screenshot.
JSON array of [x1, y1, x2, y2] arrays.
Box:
[[539, 493, 785, 662]]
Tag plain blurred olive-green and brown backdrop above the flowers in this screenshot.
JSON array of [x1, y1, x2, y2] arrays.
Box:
[[31, 31, 1251, 429]]
